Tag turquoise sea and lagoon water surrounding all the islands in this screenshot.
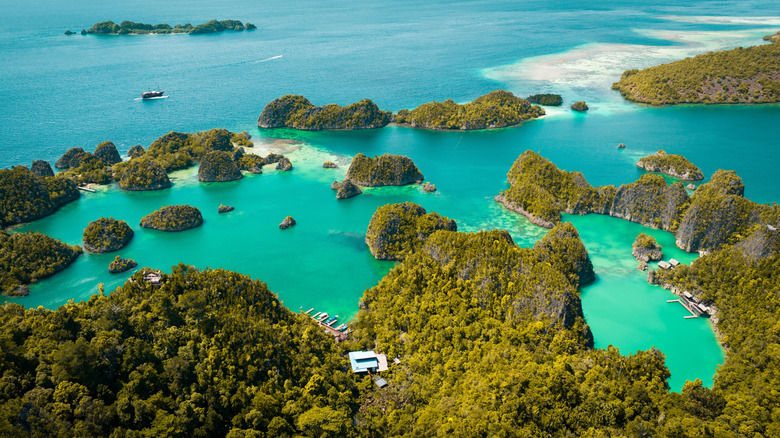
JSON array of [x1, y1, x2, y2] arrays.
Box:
[[0, 0, 780, 390]]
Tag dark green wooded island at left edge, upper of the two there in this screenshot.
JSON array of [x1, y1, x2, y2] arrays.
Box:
[[0, 166, 80, 227]]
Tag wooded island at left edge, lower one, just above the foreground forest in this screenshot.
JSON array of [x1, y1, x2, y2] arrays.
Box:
[[0, 230, 81, 296]]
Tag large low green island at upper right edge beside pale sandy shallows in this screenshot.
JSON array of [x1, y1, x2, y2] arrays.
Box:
[[612, 36, 780, 105]]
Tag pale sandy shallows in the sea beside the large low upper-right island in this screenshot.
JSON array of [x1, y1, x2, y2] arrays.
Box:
[[482, 29, 774, 115]]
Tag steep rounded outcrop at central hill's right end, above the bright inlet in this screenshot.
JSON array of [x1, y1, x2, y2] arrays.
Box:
[[534, 222, 596, 286]]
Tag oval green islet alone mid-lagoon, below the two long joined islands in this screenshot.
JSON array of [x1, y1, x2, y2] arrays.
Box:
[[347, 153, 423, 187]]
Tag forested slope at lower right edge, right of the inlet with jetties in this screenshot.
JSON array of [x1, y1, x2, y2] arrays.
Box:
[[655, 231, 780, 436]]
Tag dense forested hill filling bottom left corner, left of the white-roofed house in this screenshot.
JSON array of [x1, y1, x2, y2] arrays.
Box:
[[0, 265, 356, 437]]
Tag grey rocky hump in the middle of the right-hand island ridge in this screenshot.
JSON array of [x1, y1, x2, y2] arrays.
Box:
[[609, 175, 688, 231]]
